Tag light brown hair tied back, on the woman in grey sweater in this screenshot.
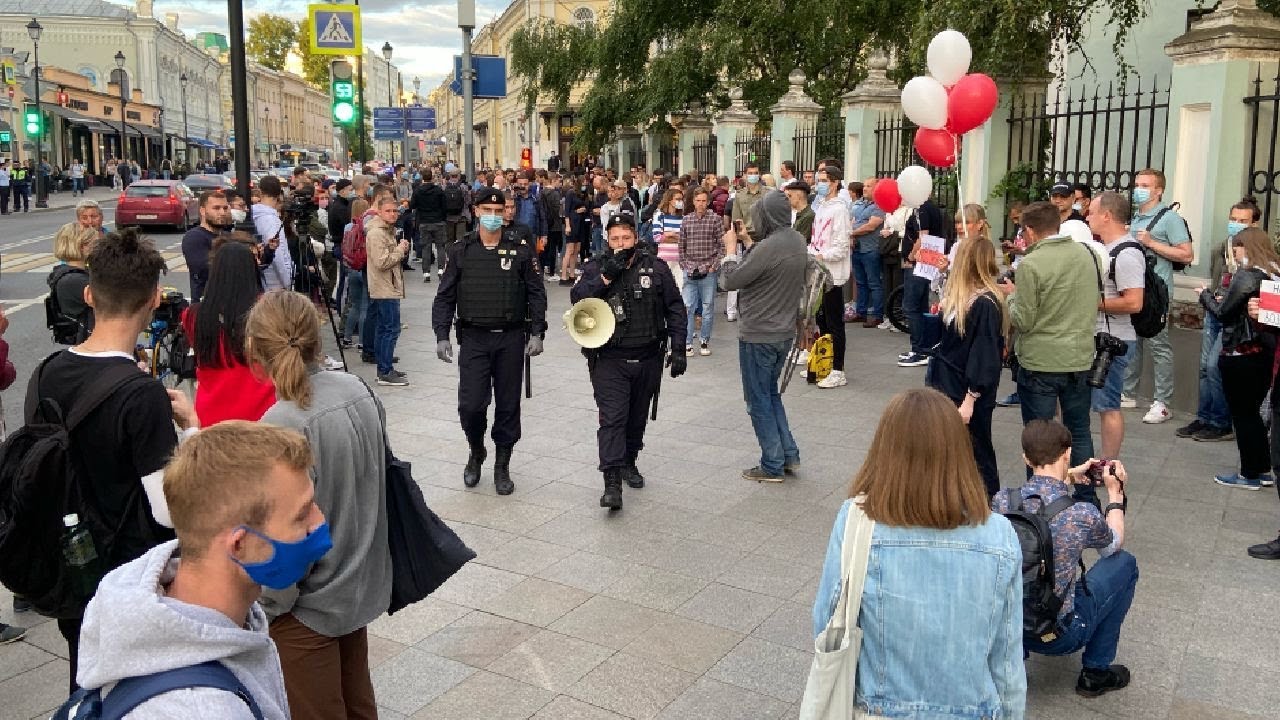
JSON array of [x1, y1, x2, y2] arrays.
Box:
[[244, 290, 320, 410]]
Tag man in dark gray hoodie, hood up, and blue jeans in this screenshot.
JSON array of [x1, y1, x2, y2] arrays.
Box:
[[719, 190, 808, 483]]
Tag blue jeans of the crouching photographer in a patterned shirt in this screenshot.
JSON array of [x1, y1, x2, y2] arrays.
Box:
[[1023, 550, 1138, 670]]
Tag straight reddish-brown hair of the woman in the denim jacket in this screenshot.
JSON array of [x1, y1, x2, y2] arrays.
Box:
[[849, 388, 991, 530]]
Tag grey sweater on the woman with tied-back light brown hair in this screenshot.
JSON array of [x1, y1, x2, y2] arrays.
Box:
[[261, 368, 392, 638]]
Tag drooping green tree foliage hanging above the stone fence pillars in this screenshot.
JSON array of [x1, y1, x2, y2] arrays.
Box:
[[509, 0, 1157, 150]]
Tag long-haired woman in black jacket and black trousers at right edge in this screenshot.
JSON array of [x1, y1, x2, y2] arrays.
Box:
[[1199, 228, 1280, 491]]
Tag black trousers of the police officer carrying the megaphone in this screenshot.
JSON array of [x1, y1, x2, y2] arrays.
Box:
[[589, 350, 663, 471]]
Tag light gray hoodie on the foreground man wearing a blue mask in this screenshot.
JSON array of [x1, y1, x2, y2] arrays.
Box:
[[76, 541, 289, 720]]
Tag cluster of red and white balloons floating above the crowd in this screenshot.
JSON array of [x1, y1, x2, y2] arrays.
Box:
[[873, 29, 998, 213]]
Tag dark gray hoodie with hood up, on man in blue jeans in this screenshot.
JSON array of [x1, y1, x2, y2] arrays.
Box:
[[719, 190, 808, 343]]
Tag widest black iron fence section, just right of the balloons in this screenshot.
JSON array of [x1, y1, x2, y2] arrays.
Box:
[[1000, 78, 1169, 201]]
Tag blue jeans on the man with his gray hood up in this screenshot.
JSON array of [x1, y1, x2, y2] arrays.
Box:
[[742, 338, 800, 475]]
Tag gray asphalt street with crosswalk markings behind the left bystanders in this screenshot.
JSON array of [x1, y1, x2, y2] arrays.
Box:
[[0, 200, 191, 429]]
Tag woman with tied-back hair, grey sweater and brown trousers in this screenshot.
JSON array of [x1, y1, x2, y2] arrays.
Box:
[[246, 290, 392, 720]]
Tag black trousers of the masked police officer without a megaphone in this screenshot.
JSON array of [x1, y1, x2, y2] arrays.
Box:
[[458, 328, 525, 447]]
